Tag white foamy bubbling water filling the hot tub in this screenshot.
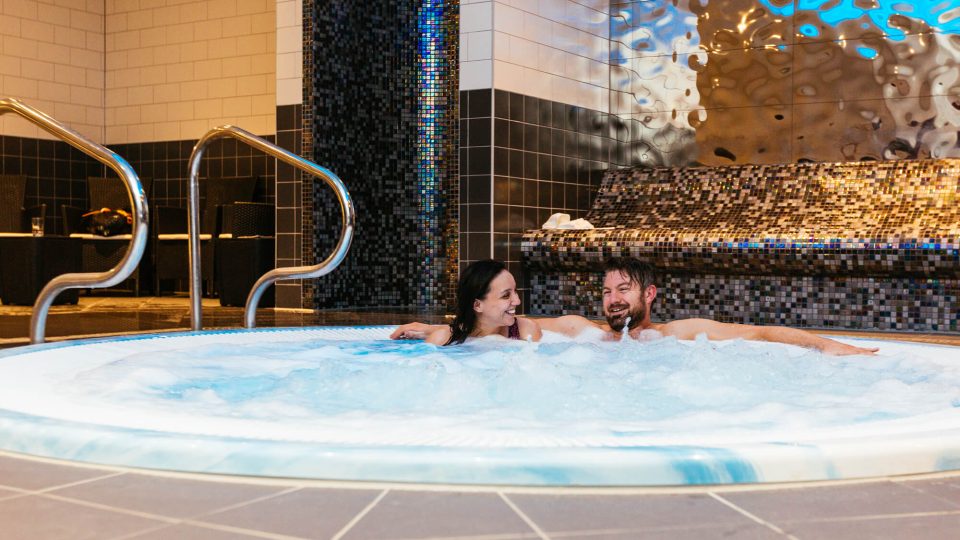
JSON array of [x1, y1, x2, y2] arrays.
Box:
[[0, 328, 960, 448]]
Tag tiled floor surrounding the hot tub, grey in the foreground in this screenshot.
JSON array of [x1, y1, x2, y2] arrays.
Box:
[[0, 297, 960, 540]]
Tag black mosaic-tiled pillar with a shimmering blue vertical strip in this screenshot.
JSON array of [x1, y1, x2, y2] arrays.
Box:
[[303, 0, 459, 308]]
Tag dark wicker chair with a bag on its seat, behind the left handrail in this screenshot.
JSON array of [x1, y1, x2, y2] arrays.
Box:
[[60, 177, 153, 296]]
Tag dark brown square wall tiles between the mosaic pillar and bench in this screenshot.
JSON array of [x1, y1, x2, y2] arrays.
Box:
[[460, 89, 618, 310]]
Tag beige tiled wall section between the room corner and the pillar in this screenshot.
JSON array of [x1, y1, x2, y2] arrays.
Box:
[[104, 0, 277, 144]]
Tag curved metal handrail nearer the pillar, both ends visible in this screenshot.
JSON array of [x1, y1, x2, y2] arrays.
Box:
[[187, 125, 356, 330]]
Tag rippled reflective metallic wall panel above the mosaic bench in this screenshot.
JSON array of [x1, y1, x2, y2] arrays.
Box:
[[610, 0, 960, 166]]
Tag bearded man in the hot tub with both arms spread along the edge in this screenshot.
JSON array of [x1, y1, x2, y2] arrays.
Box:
[[390, 257, 877, 355]]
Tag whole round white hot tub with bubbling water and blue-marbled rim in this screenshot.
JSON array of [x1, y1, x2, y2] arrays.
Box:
[[0, 327, 960, 486]]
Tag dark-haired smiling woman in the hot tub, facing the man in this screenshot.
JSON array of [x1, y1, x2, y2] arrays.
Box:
[[426, 259, 543, 345]]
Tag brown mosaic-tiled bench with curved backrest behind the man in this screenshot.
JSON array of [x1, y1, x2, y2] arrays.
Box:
[[523, 160, 960, 331]]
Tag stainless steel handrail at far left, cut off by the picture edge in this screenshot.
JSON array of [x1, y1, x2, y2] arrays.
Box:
[[0, 98, 149, 343]]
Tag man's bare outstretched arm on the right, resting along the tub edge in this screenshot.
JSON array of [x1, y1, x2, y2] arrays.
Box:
[[660, 319, 879, 356]]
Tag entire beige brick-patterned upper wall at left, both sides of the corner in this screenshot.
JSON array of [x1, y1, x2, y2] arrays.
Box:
[[0, 0, 278, 144]]
